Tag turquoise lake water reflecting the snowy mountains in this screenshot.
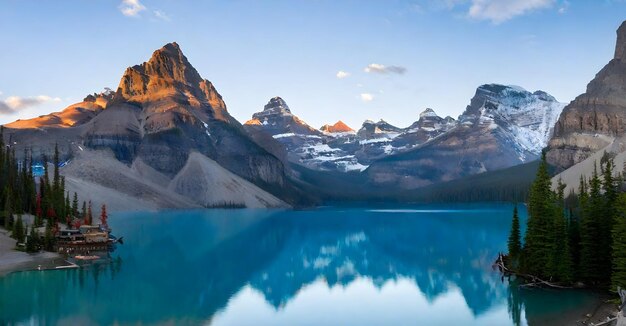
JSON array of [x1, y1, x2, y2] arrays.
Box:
[[0, 204, 597, 325]]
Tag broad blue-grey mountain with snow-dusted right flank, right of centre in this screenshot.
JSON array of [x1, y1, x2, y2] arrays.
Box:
[[365, 84, 563, 189]]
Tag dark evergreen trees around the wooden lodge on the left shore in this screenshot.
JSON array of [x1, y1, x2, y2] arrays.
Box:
[[0, 126, 107, 251]]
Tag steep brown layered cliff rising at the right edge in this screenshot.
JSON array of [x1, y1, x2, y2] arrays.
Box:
[[546, 22, 626, 170]]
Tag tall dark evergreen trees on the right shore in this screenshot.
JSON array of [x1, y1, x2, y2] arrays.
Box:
[[506, 153, 626, 289]]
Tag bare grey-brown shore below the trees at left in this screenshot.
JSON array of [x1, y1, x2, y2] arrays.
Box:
[[0, 229, 65, 277]]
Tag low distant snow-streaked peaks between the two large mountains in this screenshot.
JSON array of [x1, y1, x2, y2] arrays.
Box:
[[244, 97, 456, 172]]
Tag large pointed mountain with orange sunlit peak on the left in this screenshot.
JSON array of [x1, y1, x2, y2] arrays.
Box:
[[7, 43, 293, 206]]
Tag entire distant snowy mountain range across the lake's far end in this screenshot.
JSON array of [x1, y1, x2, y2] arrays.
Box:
[[244, 84, 565, 189]]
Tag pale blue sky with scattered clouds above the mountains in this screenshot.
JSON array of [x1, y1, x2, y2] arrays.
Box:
[[0, 0, 626, 129]]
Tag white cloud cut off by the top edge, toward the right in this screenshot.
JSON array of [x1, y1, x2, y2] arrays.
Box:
[[468, 0, 556, 24]]
